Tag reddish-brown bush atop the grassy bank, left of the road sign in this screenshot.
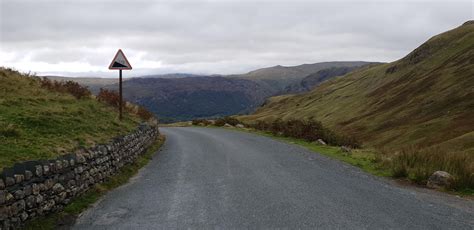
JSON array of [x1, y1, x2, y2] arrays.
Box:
[[40, 78, 91, 99]]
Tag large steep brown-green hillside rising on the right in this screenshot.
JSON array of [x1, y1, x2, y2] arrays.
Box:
[[241, 21, 474, 151]]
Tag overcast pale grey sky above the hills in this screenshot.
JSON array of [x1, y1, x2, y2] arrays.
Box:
[[0, 0, 474, 77]]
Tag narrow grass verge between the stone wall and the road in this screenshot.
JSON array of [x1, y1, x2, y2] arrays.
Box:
[[25, 136, 165, 230]]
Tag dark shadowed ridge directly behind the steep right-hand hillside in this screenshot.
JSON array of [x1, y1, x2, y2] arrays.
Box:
[[281, 63, 375, 94]]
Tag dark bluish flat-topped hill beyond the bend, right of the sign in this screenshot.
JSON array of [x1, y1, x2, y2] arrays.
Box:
[[114, 77, 272, 122]]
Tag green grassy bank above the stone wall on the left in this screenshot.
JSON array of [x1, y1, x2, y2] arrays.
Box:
[[0, 68, 140, 169]]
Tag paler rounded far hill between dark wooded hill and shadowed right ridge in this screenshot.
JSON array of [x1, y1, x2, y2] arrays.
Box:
[[235, 61, 368, 93]]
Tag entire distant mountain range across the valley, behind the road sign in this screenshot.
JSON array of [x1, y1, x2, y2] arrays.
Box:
[[50, 62, 371, 122]]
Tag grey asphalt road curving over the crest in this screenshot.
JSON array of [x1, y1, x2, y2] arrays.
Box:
[[74, 128, 474, 229]]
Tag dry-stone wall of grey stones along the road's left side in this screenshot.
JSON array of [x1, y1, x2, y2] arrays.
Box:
[[0, 124, 159, 229]]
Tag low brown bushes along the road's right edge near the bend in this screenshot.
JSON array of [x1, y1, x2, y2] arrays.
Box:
[[249, 119, 360, 148]]
